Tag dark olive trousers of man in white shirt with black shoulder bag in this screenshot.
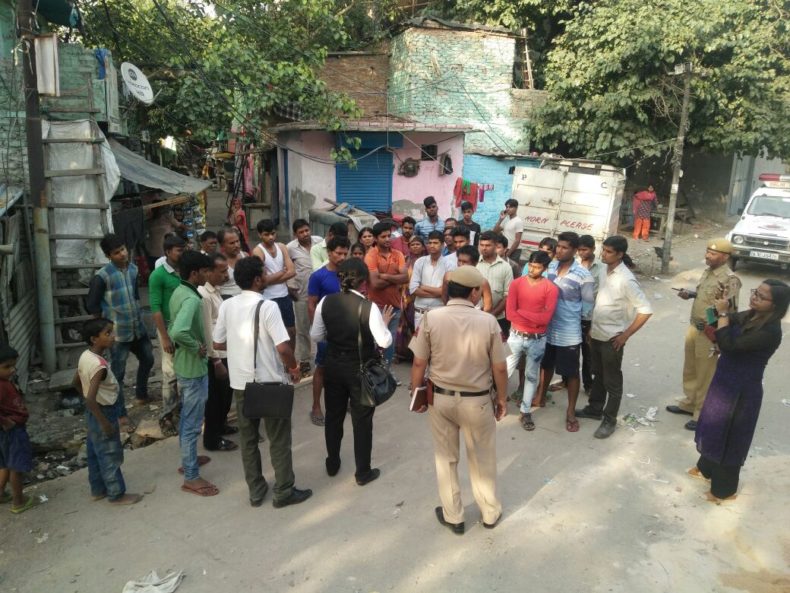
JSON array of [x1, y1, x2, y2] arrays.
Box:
[[233, 389, 294, 501]]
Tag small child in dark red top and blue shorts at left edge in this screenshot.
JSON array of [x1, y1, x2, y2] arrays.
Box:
[[0, 344, 38, 513]]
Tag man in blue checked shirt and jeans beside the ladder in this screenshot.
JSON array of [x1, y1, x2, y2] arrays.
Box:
[[85, 234, 154, 430]]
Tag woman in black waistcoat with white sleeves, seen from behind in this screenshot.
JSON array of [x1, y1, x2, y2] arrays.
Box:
[[310, 258, 392, 486]]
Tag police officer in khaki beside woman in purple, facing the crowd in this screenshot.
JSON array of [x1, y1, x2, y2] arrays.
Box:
[[667, 239, 741, 430]]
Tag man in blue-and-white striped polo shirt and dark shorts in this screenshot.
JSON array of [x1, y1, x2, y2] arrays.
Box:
[[538, 231, 595, 432]]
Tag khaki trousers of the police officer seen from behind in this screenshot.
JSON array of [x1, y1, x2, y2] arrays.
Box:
[[428, 393, 502, 523]]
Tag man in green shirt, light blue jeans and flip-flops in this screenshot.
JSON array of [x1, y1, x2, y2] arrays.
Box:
[[169, 251, 219, 496]]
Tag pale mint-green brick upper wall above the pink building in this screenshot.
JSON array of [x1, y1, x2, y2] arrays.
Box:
[[388, 27, 539, 154]]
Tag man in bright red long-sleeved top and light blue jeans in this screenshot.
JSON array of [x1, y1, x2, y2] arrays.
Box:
[[505, 251, 560, 430]]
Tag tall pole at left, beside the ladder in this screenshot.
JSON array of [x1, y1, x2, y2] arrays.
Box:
[[16, 0, 57, 373]]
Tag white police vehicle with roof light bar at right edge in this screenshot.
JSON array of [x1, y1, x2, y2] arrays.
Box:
[[727, 173, 790, 270]]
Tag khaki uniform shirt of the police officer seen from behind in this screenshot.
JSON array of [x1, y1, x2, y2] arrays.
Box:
[[409, 299, 507, 392]]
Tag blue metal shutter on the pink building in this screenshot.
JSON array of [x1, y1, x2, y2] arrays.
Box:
[[335, 148, 392, 213]]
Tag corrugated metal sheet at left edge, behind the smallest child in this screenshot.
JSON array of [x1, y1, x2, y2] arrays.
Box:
[[0, 209, 38, 390]]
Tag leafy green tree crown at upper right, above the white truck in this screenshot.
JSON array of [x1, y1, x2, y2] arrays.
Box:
[[530, 0, 790, 157]]
